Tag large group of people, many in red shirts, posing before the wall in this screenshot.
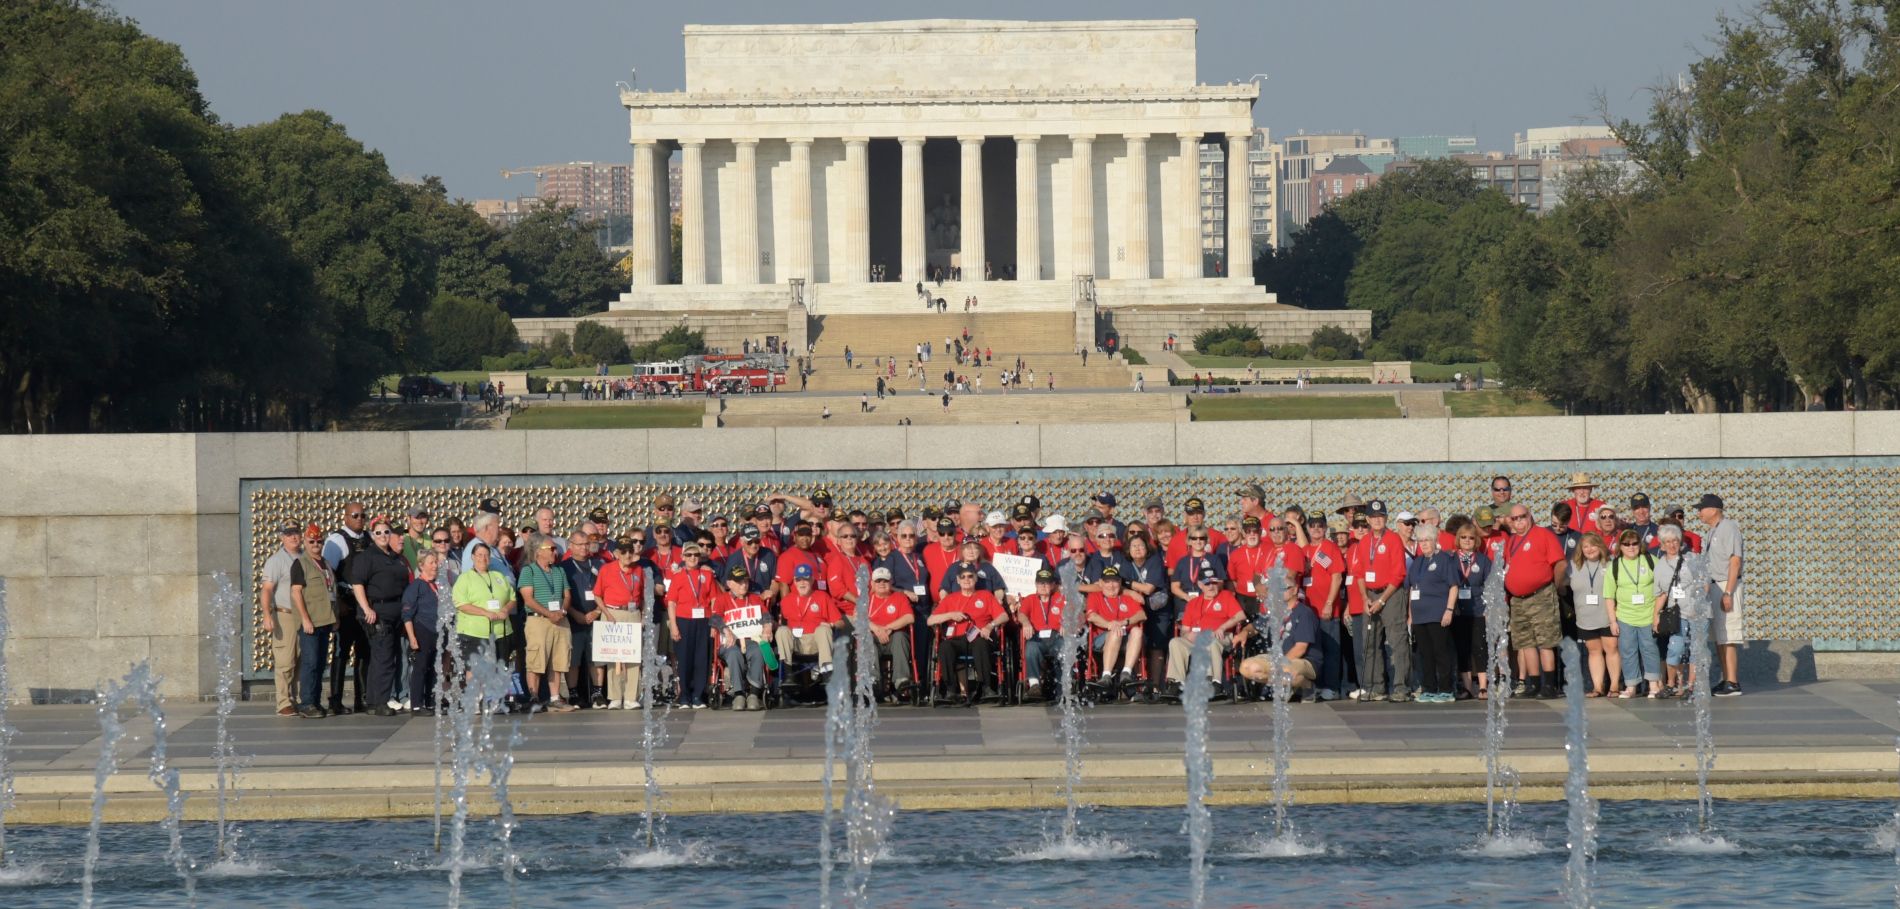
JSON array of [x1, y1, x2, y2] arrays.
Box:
[[260, 474, 1746, 719]]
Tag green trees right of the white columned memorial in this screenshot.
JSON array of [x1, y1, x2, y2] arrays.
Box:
[[1256, 0, 1900, 413]]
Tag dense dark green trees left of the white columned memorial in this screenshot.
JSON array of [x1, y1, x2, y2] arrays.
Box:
[[0, 0, 621, 432]]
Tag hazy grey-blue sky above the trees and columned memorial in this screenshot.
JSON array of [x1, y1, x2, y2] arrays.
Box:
[[116, 0, 1746, 198]]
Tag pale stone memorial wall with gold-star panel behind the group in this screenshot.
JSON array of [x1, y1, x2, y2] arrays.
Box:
[[0, 413, 1900, 702]]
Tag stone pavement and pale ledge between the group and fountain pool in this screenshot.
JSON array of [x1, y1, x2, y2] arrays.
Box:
[[8, 681, 1900, 823]]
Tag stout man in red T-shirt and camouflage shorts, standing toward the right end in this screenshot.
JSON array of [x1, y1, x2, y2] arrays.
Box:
[[1499, 502, 1588, 700]]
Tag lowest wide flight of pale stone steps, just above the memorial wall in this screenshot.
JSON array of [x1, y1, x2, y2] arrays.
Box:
[[707, 392, 1188, 426]]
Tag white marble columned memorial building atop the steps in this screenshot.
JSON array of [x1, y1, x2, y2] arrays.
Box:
[[616, 19, 1258, 308]]
